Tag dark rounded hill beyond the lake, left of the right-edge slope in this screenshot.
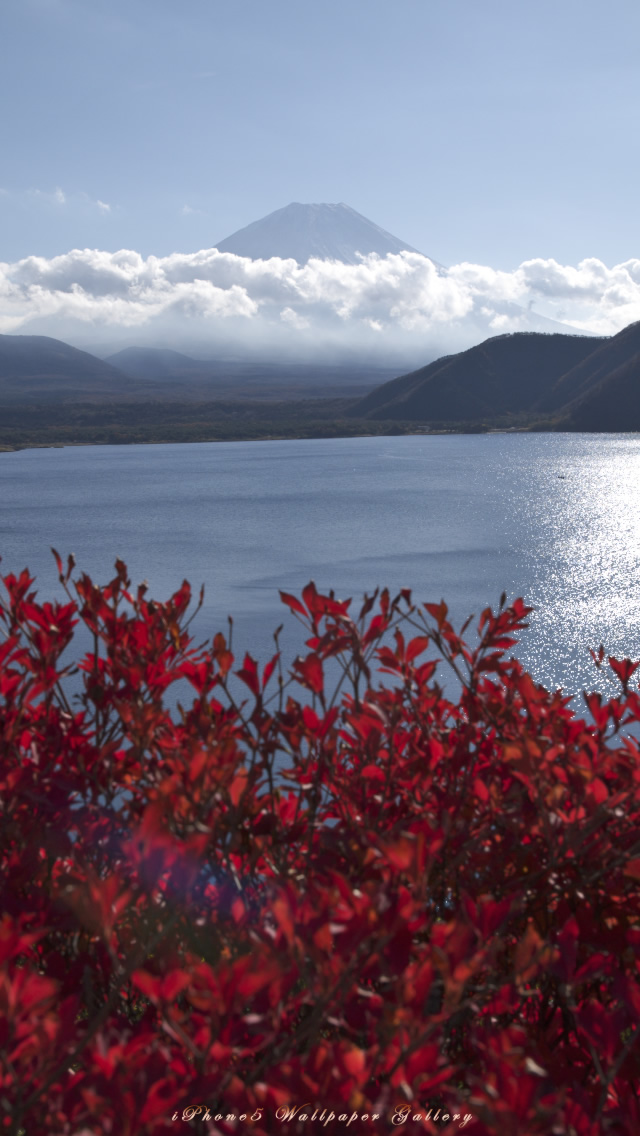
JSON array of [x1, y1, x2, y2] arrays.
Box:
[[352, 332, 605, 421]]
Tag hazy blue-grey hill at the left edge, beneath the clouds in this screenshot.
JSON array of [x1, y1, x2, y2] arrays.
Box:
[[0, 335, 131, 402]]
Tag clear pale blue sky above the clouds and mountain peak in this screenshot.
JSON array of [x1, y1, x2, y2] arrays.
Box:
[[5, 0, 640, 269]]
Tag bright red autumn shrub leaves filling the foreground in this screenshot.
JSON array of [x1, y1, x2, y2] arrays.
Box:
[[0, 558, 640, 1136]]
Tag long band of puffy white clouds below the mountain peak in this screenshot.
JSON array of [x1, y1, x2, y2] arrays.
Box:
[[0, 247, 640, 353]]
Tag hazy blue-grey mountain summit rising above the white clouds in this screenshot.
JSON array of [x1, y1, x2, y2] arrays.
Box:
[[216, 201, 441, 267]]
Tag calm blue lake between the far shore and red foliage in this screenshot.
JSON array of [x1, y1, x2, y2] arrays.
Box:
[[0, 434, 640, 693]]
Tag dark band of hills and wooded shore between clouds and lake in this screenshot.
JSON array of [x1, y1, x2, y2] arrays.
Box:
[[5, 323, 640, 440]]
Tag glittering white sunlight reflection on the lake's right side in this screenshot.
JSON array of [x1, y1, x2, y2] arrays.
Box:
[[513, 435, 640, 691]]
